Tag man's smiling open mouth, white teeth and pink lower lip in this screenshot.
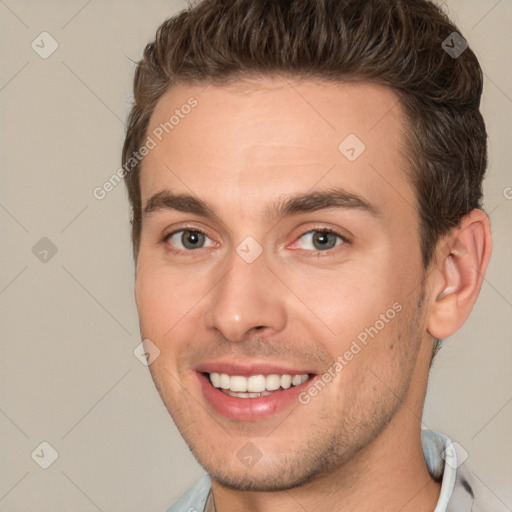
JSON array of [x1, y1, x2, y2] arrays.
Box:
[[195, 368, 321, 422]]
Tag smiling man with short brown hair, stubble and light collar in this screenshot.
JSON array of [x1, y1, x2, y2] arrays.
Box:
[[123, 0, 492, 512]]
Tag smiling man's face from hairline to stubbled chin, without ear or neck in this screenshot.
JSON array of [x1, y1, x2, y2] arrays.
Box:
[[136, 79, 432, 490]]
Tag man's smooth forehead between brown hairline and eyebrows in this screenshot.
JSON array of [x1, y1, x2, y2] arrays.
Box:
[[141, 78, 415, 223]]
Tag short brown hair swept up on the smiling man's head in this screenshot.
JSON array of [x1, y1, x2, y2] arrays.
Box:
[[123, 0, 487, 268]]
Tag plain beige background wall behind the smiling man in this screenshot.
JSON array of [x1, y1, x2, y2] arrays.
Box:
[[0, 0, 512, 512]]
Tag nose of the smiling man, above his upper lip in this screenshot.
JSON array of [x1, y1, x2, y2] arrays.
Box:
[[204, 249, 287, 342]]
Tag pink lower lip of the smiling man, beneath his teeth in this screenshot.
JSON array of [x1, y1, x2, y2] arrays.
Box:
[[196, 372, 316, 421]]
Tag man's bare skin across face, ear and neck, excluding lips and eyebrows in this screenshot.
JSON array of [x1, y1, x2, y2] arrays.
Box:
[[135, 77, 490, 512]]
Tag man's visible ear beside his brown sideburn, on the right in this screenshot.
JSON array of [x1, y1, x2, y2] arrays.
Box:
[[427, 209, 492, 339]]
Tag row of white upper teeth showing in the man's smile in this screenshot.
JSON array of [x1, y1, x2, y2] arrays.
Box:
[[210, 372, 309, 398]]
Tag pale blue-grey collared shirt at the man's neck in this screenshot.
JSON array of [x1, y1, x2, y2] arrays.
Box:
[[166, 430, 502, 512]]
